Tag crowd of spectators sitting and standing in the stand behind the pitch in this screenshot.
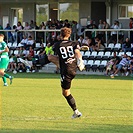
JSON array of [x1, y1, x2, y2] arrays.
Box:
[[0, 18, 133, 75]]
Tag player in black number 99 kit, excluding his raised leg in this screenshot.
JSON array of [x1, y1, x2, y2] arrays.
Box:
[[55, 27, 84, 118]]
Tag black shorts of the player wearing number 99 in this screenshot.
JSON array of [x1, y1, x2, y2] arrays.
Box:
[[61, 73, 76, 89]]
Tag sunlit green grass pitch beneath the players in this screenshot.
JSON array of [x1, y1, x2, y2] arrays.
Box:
[[0, 73, 133, 133]]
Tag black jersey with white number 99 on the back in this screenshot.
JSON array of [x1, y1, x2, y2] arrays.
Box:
[[55, 41, 78, 75]]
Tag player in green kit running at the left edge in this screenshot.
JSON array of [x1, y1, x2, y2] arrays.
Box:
[[0, 34, 13, 86]]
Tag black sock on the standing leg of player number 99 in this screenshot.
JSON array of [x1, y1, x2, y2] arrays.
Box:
[[65, 94, 77, 111]]
